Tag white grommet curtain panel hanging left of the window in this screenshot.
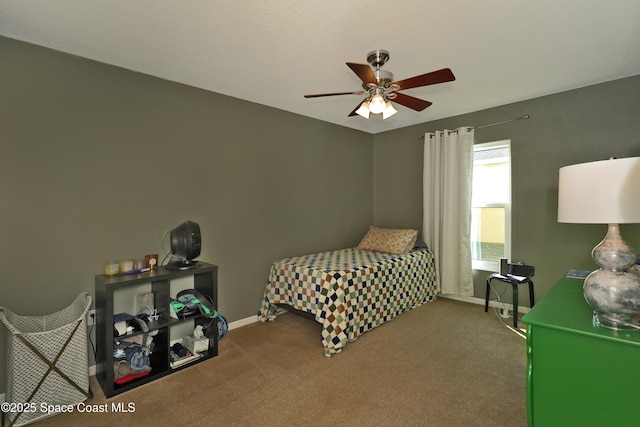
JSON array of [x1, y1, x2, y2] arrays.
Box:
[[422, 127, 473, 296]]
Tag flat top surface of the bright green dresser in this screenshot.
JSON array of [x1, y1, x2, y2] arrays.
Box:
[[522, 277, 640, 347]]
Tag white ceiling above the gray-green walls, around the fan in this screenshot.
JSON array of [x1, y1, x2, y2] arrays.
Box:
[[0, 0, 640, 133]]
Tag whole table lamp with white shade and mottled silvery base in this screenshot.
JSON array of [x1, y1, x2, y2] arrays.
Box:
[[558, 157, 640, 329]]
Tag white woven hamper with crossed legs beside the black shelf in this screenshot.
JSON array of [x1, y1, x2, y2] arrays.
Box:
[[0, 292, 91, 426]]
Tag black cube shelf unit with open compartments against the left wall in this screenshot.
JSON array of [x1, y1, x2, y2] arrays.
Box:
[[95, 262, 218, 397]]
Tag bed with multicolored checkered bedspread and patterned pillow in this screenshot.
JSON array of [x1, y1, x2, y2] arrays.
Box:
[[258, 226, 438, 357]]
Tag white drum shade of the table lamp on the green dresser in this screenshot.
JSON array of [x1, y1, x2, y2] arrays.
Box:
[[558, 157, 640, 224]]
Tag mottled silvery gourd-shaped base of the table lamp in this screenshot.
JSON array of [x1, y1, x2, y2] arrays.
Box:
[[583, 224, 640, 330]]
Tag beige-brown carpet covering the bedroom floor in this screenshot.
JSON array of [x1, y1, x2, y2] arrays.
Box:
[[28, 299, 526, 427]]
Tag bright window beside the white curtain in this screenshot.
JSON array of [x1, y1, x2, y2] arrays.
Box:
[[471, 140, 511, 271]]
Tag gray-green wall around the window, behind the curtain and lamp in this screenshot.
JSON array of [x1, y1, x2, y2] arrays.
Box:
[[373, 76, 640, 306]]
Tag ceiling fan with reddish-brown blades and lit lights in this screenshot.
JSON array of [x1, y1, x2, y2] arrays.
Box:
[[304, 49, 456, 119]]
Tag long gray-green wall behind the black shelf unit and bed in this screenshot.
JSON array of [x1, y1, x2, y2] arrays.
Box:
[[0, 38, 373, 393]]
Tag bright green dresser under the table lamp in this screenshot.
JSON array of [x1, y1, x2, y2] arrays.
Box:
[[522, 277, 640, 427]]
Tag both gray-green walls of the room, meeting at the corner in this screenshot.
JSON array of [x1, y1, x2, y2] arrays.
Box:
[[0, 37, 640, 393]]
